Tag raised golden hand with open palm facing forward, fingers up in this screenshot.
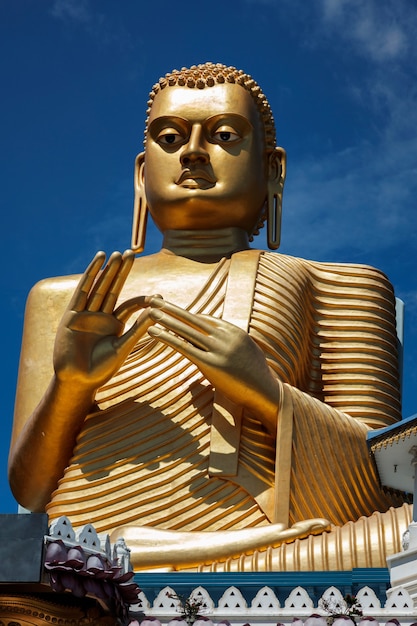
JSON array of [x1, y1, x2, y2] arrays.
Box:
[[54, 250, 153, 392]]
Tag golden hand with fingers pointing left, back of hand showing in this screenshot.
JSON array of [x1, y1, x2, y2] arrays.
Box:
[[148, 297, 280, 434]]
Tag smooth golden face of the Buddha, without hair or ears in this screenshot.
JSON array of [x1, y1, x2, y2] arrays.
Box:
[[144, 84, 268, 233]]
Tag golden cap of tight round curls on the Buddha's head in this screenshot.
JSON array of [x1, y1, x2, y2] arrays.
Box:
[[145, 62, 276, 150]]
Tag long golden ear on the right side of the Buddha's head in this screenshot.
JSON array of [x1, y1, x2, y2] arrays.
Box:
[[266, 147, 287, 250]]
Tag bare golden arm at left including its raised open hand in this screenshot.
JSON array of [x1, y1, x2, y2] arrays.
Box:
[[9, 253, 149, 511]]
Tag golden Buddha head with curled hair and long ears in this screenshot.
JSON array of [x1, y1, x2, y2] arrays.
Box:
[[132, 63, 285, 250]]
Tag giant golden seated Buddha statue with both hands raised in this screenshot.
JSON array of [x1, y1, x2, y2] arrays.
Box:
[[10, 63, 410, 571]]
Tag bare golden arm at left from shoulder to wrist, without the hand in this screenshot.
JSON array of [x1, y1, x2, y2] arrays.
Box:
[[9, 277, 91, 511]]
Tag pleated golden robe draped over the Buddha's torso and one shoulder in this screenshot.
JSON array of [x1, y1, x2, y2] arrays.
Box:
[[47, 250, 402, 544]]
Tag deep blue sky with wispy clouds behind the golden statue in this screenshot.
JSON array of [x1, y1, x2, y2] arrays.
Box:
[[0, 0, 417, 512]]
